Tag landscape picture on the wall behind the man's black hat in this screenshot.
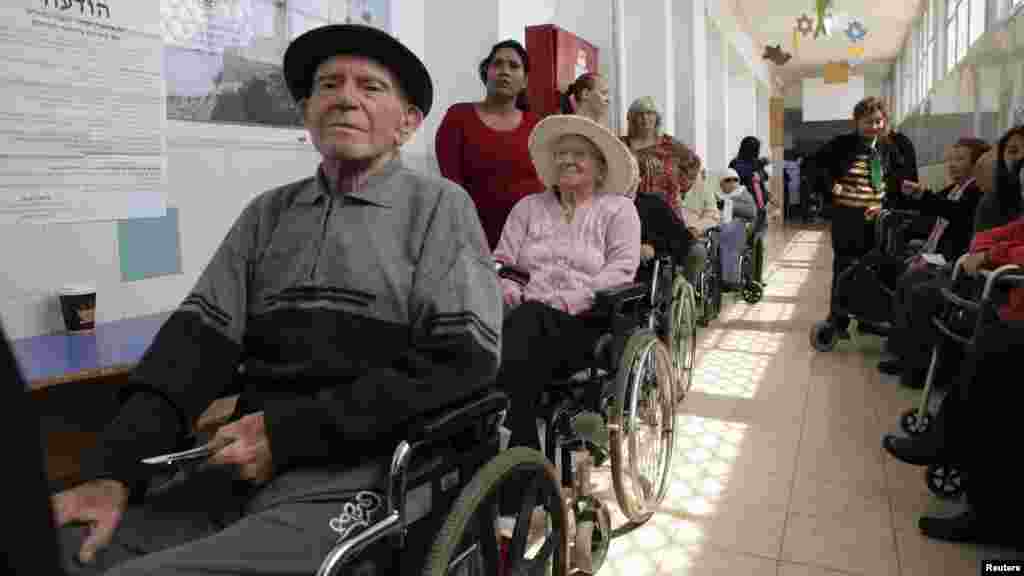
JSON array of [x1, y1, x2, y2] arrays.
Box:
[[161, 0, 390, 128]]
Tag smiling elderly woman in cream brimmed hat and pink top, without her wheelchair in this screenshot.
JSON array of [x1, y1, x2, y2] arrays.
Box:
[[495, 116, 640, 516]]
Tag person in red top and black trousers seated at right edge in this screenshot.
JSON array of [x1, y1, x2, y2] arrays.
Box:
[[883, 203, 1024, 548]]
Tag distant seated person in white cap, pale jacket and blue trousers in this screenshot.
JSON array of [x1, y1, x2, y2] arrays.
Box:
[[718, 168, 758, 292]]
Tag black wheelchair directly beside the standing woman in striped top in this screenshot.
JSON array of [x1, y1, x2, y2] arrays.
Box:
[[810, 210, 921, 352]]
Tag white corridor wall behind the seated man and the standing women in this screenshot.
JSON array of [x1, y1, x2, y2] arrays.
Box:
[[0, 0, 790, 337]]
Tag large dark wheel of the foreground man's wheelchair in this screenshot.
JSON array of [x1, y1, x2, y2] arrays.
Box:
[[423, 447, 569, 576]]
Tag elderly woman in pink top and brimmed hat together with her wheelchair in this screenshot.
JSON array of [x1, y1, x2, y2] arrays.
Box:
[[495, 116, 675, 572]]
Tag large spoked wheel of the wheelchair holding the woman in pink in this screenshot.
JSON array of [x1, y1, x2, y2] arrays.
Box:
[[608, 330, 676, 524]]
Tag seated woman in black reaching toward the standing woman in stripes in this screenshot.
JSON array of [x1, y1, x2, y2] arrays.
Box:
[[879, 138, 991, 374]]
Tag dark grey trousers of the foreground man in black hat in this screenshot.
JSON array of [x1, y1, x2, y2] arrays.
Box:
[[60, 465, 389, 576]]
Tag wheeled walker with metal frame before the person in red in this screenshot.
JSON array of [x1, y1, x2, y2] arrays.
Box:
[[899, 254, 1024, 498]]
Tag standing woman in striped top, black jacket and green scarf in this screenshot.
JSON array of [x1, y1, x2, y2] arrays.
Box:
[[816, 96, 918, 339]]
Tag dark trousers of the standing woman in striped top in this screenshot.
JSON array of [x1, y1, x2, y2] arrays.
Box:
[[828, 206, 874, 331]]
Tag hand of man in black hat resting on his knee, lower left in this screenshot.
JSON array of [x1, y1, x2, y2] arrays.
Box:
[[52, 480, 128, 564]]
